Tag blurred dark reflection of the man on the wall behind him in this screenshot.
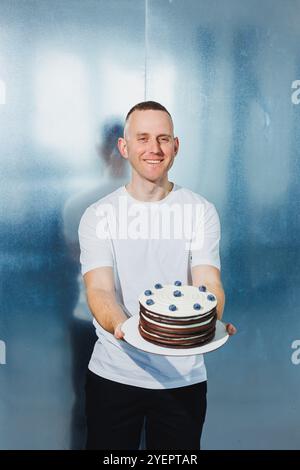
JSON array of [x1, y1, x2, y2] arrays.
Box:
[[63, 120, 128, 449]]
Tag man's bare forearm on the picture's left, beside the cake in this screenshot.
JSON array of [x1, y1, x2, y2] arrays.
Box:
[[83, 266, 128, 339]]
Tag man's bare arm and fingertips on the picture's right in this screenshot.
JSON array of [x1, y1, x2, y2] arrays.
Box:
[[191, 264, 236, 334]]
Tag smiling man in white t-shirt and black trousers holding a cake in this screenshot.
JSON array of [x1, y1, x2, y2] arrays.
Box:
[[79, 101, 236, 450]]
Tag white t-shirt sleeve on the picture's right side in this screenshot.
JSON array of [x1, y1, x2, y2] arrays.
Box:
[[191, 202, 221, 269]]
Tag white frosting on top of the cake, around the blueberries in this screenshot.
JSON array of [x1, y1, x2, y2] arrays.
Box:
[[139, 284, 217, 320]]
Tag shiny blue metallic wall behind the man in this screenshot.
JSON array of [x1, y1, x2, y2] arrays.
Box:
[[0, 0, 300, 449]]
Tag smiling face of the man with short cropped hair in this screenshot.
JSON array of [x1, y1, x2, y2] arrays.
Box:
[[118, 110, 179, 182]]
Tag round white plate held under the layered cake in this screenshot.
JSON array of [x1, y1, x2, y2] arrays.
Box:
[[121, 314, 229, 356]]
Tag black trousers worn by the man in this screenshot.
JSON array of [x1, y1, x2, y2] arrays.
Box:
[[86, 371, 207, 450]]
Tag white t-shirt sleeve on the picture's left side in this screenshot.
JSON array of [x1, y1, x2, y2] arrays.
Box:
[[78, 206, 114, 275]]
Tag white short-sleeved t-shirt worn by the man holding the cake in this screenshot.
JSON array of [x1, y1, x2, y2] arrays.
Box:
[[78, 184, 220, 389]]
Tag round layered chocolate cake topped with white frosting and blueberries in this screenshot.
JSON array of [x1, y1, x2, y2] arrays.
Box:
[[138, 281, 217, 349]]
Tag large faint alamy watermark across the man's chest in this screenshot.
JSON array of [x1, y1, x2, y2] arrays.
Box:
[[96, 196, 204, 250]]
